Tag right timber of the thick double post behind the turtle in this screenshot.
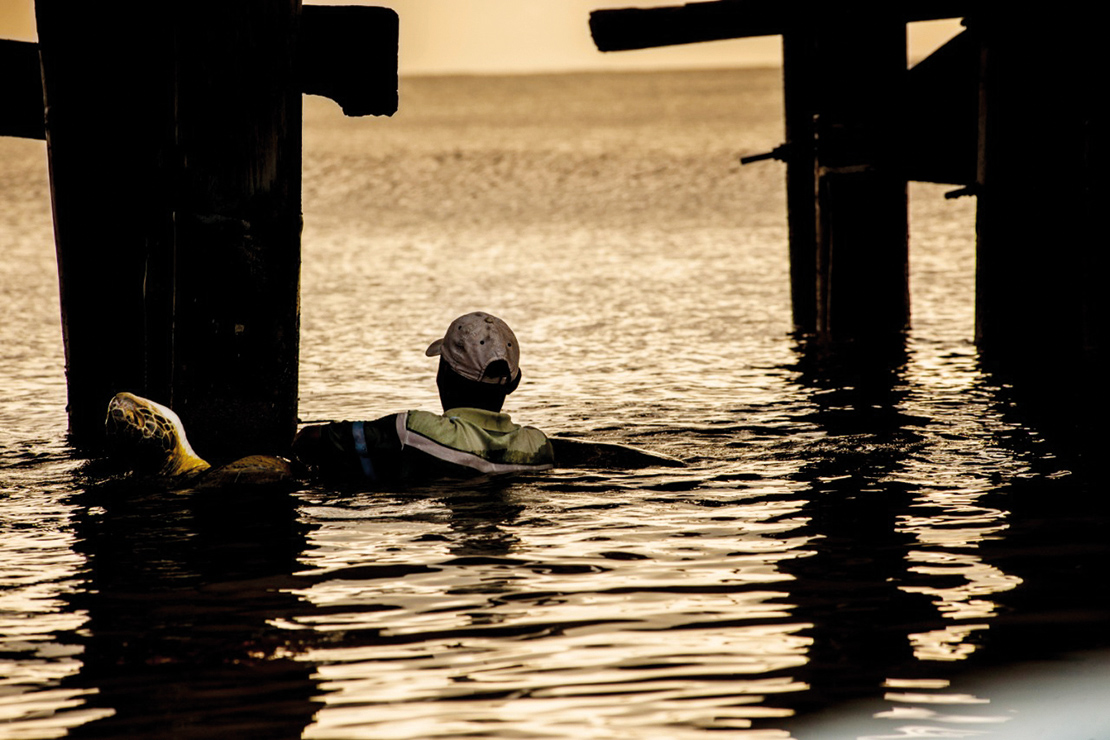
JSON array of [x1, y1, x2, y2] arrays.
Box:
[[171, 0, 301, 458]]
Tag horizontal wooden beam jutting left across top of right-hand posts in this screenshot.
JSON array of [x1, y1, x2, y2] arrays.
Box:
[[589, 0, 980, 51]]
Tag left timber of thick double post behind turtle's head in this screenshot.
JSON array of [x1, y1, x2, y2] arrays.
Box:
[[36, 0, 173, 446]]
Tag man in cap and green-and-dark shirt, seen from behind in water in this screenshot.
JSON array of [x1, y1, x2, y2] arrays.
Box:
[[293, 312, 555, 484]]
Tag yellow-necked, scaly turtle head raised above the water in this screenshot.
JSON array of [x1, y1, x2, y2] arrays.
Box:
[[104, 393, 209, 475]]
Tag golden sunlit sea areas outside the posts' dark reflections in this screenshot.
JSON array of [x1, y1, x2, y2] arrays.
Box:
[[0, 72, 1106, 740]]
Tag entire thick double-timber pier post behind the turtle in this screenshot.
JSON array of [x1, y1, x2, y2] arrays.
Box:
[[37, 0, 301, 459]]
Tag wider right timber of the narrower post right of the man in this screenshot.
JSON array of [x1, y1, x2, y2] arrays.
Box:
[[814, 10, 909, 341]]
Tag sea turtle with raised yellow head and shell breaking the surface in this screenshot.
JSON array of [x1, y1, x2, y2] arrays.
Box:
[[104, 393, 293, 488]]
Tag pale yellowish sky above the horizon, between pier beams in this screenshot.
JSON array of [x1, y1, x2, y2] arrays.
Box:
[[0, 0, 960, 74]]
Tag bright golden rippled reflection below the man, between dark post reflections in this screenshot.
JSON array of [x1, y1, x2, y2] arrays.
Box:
[[287, 491, 813, 740]]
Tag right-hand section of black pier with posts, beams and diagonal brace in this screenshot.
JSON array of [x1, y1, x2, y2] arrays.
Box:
[[591, 0, 1110, 445]]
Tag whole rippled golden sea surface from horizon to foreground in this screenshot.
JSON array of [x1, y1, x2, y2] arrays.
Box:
[[0, 70, 1110, 740]]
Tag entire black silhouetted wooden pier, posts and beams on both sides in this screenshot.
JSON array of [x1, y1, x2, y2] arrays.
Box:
[[0, 0, 1108, 460]]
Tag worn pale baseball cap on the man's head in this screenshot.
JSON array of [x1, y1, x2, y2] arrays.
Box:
[[424, 311, 521, 385]]
